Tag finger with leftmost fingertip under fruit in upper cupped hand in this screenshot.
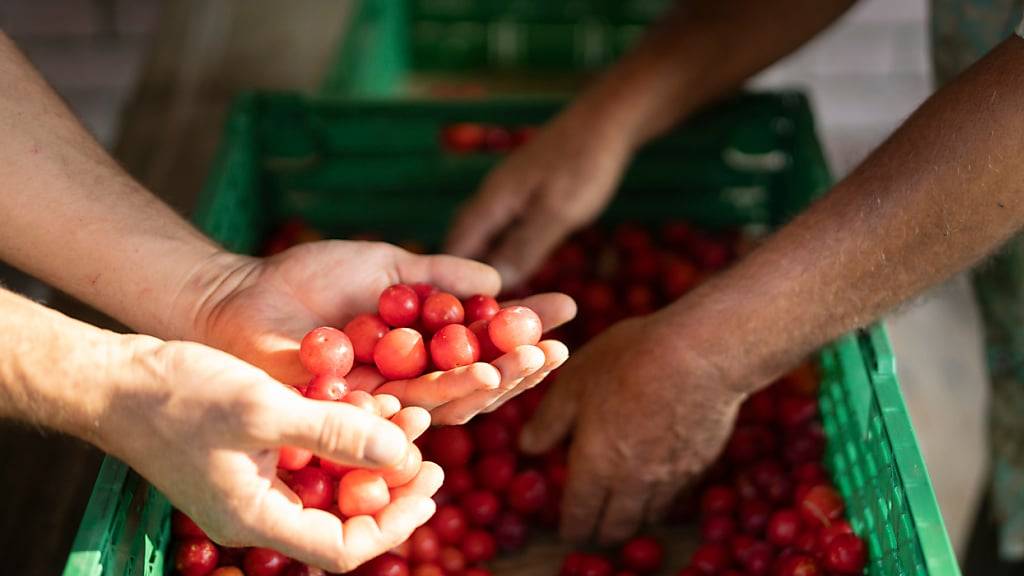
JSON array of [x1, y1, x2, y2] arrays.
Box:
[[377, 362, 502, 410]]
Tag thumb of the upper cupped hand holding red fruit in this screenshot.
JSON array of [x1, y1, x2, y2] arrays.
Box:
[[395, 252, 502, 298]]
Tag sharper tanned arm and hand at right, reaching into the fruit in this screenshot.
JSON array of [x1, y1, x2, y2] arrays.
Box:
[[521, 37, 1024, 541]]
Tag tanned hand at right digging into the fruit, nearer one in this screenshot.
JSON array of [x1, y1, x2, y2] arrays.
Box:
[[520, 315, 743, 543]]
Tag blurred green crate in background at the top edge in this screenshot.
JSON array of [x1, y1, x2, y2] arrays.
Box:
[[324, 0, 672, 97]]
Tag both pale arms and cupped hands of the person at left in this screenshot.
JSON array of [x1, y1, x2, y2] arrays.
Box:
[[0, 34, 575, 572]]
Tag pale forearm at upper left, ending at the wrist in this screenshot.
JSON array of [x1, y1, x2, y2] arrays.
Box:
[[0, 33, 234, 337]]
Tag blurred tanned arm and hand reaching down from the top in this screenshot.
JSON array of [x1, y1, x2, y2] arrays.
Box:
[[446, 0, 853, 285]]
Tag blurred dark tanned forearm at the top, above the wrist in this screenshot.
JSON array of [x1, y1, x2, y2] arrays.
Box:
[[579, 0, 855, 146]]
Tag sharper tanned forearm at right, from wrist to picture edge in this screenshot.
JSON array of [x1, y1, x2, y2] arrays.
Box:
[[666, 38, 1024, 386]]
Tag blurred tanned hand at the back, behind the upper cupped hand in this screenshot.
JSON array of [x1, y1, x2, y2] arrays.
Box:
[[446, 104, 633, 286]]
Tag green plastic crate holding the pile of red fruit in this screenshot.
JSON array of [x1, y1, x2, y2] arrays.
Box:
[[65, 93, 959, 576]]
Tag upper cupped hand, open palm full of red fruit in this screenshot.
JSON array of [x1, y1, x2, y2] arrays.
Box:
[[179, 241, 575, 423]]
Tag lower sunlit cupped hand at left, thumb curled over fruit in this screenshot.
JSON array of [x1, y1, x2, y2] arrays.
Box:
[[96, 337, 443, 572]]
